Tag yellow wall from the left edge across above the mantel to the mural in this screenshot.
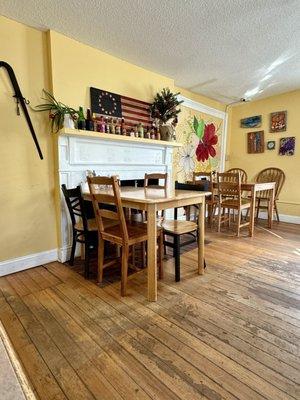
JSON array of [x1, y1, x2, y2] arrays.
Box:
[[0, 21, 222, 261]]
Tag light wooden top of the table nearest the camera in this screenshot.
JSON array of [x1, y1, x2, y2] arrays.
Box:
[[83, 186, 211, 204]]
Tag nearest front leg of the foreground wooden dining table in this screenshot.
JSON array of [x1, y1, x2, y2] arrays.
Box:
[[147, 204, 157, 301]]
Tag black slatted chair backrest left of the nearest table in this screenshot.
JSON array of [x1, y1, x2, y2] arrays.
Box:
[[61, 184, 87, 231]]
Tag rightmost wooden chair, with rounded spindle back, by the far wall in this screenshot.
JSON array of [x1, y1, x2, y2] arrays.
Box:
[[256, 167, 285, 222]]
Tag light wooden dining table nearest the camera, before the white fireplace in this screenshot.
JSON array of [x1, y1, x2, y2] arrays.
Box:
[[83, 186, 211, 301]]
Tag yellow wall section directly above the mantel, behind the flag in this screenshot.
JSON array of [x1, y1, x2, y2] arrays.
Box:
[[50, 31, 174, 108]]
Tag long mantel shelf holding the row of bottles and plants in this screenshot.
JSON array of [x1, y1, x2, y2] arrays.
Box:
[[59, 128, 182, 147]]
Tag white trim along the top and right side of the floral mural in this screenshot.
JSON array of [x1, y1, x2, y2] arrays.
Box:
[[177, 95, 228, 172]]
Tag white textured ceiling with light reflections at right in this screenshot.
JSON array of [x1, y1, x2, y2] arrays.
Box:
[[0, 0, 300, 103]]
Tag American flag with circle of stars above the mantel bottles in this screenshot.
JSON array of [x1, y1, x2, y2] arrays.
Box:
[[90, 87, 153, 128]]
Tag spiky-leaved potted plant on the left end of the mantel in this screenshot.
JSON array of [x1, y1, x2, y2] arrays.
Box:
[[34, 89, 78, 133]]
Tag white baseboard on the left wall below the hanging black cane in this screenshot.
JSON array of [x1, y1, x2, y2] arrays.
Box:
[[0, 249, 58, 276]]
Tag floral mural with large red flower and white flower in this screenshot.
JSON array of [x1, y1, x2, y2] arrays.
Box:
[[174, 106, 223, 182]]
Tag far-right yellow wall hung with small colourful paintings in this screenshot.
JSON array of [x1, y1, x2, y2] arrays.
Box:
[[227, 90, 300, 216]]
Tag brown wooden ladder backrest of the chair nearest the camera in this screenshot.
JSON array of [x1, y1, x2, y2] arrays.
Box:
[[87, 176, 128, 242]]
